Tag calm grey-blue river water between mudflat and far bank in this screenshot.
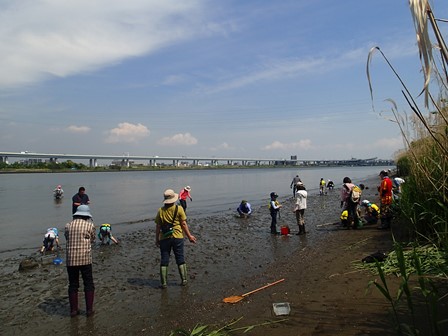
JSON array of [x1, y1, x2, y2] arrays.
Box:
[[0, 167, 388, 257]]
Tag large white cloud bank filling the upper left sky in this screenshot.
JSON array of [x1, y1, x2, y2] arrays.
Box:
[[0, 0, 207, 88]]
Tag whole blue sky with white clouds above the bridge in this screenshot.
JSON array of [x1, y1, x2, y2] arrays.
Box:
[[0, 0, 448, 160]]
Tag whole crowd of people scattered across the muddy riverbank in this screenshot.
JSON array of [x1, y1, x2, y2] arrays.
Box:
[[41, 170, 404, 317]]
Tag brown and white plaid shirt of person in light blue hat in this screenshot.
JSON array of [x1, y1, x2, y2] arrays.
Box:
[[64, 218, 96, 266]]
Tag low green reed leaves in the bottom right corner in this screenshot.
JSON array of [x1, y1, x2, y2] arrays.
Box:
[[369, 242, 448, 336]]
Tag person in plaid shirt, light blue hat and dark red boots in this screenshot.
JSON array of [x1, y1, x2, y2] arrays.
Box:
[[64, 204, 96, 317]]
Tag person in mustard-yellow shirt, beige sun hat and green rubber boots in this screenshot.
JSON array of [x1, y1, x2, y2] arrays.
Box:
[[154, 189, 196, 289]]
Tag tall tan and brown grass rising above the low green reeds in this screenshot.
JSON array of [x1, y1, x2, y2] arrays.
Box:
[[367, 0, 448, 247]]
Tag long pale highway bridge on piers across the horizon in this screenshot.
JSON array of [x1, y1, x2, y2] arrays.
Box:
[[0, 151, 393, 167]]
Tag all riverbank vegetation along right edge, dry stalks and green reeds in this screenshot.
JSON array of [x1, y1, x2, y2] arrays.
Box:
[[367, 0, 448, 335]]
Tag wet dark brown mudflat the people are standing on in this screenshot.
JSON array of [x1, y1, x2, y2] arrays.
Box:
[[0, 179, 402, 336]]
